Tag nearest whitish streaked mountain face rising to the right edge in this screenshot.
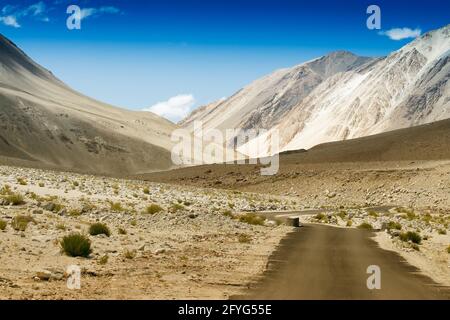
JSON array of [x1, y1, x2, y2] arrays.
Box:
[[243, 25, 450, 156]]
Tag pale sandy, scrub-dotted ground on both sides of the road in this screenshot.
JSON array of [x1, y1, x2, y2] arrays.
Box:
[[0, 162, 450, 299]]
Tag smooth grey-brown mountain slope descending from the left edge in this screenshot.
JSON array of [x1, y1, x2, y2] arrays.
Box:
[[0, 36, 176, 174]]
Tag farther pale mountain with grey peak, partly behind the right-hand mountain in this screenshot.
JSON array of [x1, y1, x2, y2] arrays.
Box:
[[181, 51, 372, 134]]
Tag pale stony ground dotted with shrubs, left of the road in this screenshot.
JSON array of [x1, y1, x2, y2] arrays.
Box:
[[0, 166, 299, 299]]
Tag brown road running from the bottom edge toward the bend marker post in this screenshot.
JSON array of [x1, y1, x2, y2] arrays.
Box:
[[243, 225, 450, 300]]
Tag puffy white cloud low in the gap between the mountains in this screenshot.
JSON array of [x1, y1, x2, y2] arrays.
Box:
[[143, 94, 195, 122]]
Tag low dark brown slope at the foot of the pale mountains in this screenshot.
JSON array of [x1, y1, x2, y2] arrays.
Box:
[[139, 119, 450, 188]]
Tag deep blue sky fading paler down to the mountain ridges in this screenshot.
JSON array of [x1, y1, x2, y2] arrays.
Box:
[[0, 0, 450, 120]]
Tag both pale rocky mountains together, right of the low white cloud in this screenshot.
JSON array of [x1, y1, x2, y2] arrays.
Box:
[[183, 25, 450, 156]]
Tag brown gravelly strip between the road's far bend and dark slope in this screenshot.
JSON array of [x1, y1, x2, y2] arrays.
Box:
[[144, 158, 450, 210]]
